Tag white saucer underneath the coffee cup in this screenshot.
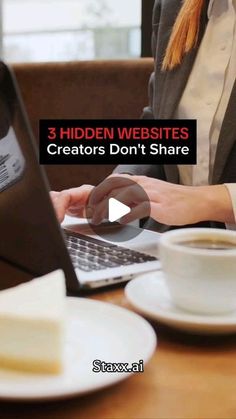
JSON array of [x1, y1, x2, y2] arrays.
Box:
[[125, 271, 236, 334]]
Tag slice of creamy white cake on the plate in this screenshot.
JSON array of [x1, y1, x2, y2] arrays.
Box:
[[0, 270, 66, 374]]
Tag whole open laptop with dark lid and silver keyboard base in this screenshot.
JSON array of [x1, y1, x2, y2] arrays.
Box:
[[0, 62, 160, 293]]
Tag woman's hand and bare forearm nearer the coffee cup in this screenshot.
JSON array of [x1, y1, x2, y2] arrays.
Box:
[[91, 174, 235, 226]]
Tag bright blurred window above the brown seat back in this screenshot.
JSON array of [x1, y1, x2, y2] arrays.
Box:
[[0, 0, 154, 62]]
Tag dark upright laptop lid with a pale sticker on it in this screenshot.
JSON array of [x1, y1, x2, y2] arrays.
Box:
[[0, 63, 78, 288]]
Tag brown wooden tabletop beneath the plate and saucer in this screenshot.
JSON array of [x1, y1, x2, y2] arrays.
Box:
[[0, 262, 236, 419]]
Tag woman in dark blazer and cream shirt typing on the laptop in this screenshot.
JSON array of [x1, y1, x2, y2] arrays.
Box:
[[52, 0, 236, 231]]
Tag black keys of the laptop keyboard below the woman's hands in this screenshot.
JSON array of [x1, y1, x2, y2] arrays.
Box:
[[64, 230, 157, 272]]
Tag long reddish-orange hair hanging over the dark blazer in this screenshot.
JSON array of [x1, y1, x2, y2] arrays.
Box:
[[162, 0, 205, 70]]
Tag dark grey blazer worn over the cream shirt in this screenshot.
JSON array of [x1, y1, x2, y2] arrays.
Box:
[[116, 0, 236, 231]]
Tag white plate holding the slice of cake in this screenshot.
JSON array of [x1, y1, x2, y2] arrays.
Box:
[[0, 298, 156, 401]]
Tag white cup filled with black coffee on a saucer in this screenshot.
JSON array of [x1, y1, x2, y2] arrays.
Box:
[[159, 228, 236, 315]]
